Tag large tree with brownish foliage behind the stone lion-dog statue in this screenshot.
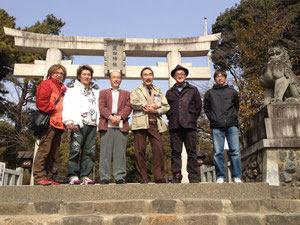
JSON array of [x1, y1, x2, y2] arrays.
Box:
[[212, 0, 300, 141]]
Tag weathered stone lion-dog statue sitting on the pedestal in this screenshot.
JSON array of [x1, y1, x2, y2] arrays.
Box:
[[259, 47, 300, 105]]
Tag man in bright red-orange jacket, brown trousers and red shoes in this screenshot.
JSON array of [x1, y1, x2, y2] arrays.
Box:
[[33, 64, 67, 185]]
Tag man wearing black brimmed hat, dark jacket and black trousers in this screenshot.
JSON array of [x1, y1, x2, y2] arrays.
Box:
[[166, 65, 202, 183]]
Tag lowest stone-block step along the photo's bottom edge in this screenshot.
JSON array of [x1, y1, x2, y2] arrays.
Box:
[[0, 213, 300, 225]]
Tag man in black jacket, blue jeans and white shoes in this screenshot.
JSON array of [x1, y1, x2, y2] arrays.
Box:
[[204, 70, 242, 183]]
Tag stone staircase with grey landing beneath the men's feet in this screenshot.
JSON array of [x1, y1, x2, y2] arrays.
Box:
[[0, 183, 300, 225]]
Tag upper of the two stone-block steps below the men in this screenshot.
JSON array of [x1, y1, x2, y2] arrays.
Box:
[[0, 199, 300, 216]]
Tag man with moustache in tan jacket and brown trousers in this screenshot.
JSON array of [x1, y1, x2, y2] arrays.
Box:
[[130, 67, 170, 183]]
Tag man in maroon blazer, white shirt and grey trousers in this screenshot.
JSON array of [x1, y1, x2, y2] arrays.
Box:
[[99, 71, 131, 184]]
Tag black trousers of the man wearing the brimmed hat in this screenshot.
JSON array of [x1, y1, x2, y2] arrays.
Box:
[[170, 127, 198, 180]]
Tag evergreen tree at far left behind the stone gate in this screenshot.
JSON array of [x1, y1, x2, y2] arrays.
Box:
[[0, 9, 65, 168]]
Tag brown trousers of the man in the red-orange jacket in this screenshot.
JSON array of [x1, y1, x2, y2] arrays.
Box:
[[33, 126, 63, 183]]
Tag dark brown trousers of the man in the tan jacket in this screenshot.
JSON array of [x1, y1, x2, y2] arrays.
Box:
[[133, 122, 164, 182]]
